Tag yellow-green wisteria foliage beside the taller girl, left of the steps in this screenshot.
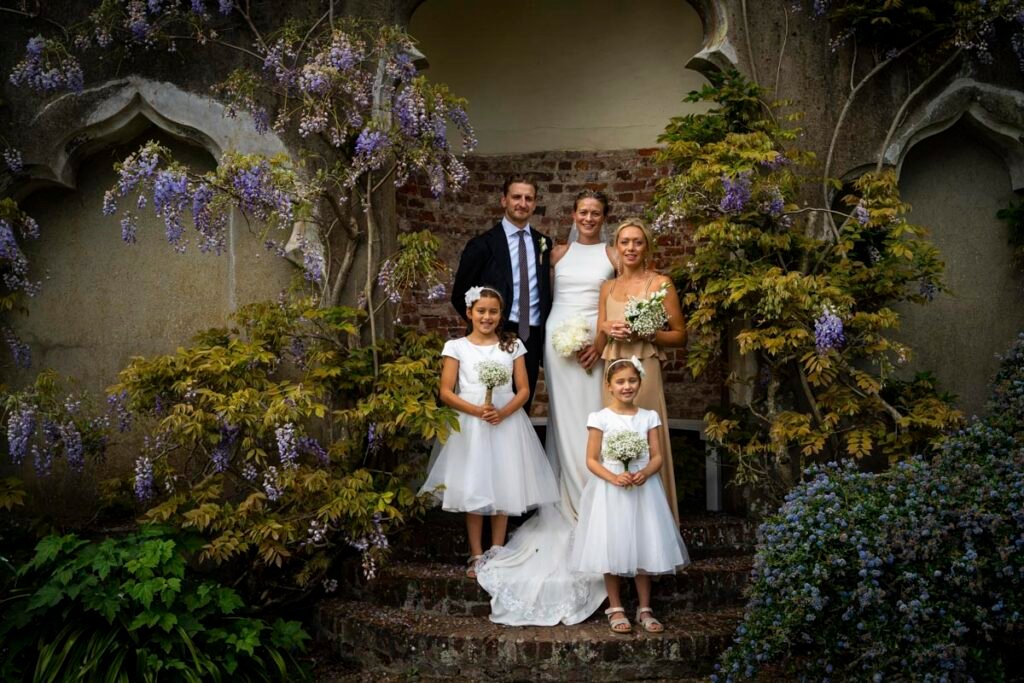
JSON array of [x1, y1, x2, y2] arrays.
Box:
[[113, 300, 458, 601]]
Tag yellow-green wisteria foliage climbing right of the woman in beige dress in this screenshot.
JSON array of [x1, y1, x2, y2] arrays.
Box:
[[654, 74, 959, 491]]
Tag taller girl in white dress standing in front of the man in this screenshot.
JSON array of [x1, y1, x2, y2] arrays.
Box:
[[420, 287, 558, 578]]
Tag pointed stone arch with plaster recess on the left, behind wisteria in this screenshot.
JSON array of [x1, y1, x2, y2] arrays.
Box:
[[10, 77, 295, 391]]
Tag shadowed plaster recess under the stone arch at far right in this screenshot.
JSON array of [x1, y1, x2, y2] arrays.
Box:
[[898, 123, 1024, 415]]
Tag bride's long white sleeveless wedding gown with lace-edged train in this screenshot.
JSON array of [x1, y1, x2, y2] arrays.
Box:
[[476, 243, 614, 626]]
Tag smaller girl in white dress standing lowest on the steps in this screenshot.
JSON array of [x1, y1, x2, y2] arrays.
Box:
[[569, 356, 690, 633]]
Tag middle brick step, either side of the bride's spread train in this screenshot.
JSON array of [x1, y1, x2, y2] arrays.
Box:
[[358, 556, 752, 616]]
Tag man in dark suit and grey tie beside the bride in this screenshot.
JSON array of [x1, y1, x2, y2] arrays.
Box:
[[452, 175, 551, 415]]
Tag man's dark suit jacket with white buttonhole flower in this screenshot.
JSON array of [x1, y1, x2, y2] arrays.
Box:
[[452, 221, 552, 327]]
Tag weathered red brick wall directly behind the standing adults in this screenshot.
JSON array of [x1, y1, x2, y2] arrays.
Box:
[[397, 150, 722, 419]]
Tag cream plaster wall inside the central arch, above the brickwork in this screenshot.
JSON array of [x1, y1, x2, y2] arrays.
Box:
[[410, 0, 706, 155]]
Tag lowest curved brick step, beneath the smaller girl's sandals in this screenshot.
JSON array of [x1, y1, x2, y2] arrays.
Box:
[[316, 599, 742, 681]]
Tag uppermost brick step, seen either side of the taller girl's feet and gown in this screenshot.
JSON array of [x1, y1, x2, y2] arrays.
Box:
[[393, 511, 757, 563]]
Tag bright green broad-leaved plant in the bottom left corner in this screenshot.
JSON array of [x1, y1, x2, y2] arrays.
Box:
[[0, 527, 308, 682]]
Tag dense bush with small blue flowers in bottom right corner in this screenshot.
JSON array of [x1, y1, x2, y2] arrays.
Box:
[[717, 335, 1024, 681]]
